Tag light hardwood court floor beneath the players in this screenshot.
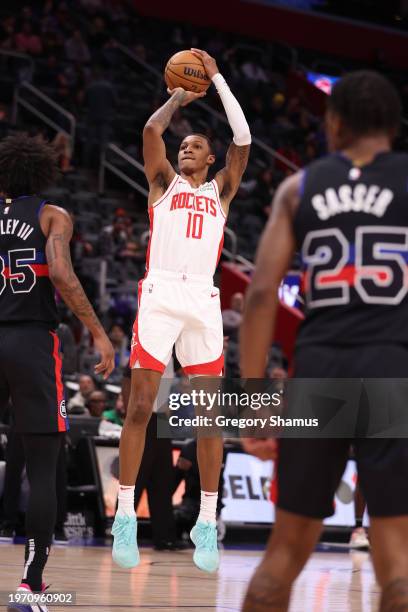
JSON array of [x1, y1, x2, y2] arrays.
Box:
[[0, 544, 378, 612]]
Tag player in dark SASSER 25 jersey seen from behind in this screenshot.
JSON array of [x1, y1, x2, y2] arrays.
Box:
[[241, 71, 408, 612]]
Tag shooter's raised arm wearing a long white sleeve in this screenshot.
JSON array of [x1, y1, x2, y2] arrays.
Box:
[[192, 49, 251, 212]]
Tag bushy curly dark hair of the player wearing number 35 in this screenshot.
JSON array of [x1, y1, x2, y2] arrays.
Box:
[[0, 132, 59, 198]]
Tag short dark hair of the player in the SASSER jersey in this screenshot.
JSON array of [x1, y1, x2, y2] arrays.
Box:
[[327, 70, 401, 137]]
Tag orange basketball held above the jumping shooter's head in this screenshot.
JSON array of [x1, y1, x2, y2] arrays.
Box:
[[164, 51, 211, 93]]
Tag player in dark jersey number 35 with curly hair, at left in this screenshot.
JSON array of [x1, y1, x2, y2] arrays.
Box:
[[0, 134, 114, 612]]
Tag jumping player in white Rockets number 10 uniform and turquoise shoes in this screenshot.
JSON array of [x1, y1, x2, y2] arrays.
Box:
[[112, 49, 251, 572]]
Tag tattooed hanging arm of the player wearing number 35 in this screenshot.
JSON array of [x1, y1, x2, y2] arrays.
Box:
[[41, 205, 114, 378]]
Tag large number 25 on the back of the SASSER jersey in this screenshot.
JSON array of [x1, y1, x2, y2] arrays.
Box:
[[302, 225, 408, 308]]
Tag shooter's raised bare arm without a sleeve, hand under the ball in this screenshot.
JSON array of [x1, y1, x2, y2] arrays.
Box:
[[143, 87, 205, 206]]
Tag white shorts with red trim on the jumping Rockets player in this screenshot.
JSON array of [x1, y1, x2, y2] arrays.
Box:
[[130, 270, 224, 376]]
